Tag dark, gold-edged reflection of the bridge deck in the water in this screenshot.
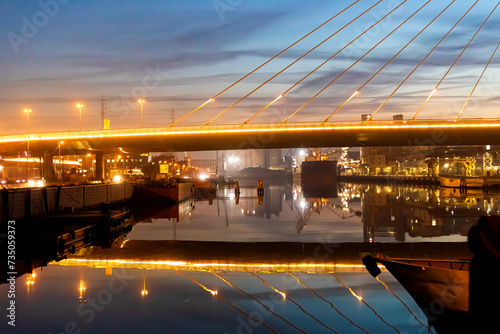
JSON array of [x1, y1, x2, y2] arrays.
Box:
[[48, 240, 470, 274]]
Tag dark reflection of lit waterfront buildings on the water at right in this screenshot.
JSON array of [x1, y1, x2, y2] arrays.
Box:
[[358, 185, 500, 242]]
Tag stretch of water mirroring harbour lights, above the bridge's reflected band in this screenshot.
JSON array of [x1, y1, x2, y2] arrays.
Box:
[[126, 182, 500, 242]]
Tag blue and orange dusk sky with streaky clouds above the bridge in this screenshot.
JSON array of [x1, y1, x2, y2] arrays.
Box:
[[0, 0, 500, 134]]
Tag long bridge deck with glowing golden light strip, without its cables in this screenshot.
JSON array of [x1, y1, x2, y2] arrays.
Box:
[[0, 119, 500, 156]]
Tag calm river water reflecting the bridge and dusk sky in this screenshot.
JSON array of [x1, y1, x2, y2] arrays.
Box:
[[0, 183, 499, 333]]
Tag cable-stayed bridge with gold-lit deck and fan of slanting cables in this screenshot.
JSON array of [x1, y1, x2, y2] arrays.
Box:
[[0, 0, 500, 154]]
